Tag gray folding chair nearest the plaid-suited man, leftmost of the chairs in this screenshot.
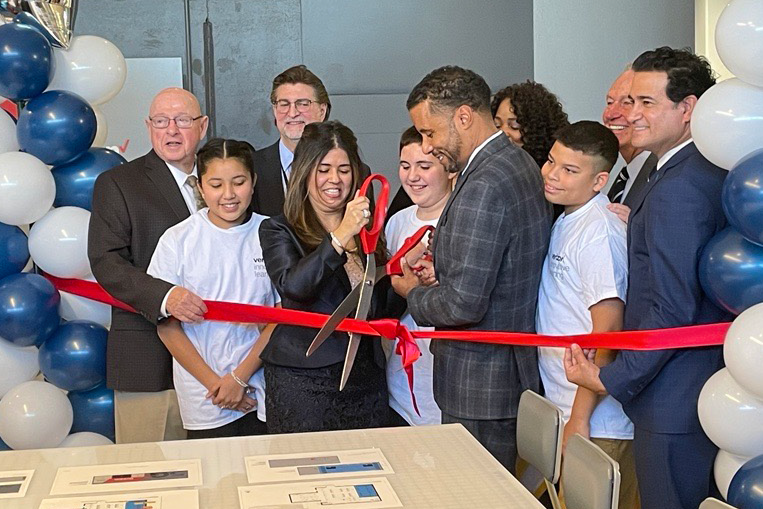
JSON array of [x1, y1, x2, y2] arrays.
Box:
[[517, 390, 564, 509]]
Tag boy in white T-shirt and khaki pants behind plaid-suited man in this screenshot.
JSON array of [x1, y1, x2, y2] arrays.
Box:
[[536, 121, 638, 509]]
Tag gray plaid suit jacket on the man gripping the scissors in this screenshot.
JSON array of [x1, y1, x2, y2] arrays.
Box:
[[408, 135, 552, 419]]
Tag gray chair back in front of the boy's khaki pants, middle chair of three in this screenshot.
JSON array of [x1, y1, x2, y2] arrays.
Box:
[[562, 433, 620, 509]]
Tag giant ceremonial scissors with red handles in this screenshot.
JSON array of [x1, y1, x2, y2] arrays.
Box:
[[305, 174, 433, 391]]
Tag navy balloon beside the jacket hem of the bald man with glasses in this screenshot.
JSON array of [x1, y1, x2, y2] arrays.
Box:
[[38, 320, 108, 391]]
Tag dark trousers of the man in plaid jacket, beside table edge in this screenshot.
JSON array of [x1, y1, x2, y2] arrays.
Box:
[[442, 412, 517, 474]]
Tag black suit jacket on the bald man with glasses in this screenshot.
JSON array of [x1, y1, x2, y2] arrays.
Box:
[[88, 150, 190, 392]]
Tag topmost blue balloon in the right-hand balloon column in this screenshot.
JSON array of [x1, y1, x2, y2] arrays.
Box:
[[722, 150, 763, 245]]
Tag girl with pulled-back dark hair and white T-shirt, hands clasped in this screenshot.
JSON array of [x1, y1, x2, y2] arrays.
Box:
[[148, 139, 280, 438]]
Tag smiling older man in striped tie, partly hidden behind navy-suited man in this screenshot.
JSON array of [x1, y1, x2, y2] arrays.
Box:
[[602, 68, 657, 223]]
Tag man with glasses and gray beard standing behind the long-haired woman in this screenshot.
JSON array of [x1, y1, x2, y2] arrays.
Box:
[[252, 65, 331, 216]]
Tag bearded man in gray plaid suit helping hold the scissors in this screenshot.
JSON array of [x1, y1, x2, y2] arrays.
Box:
[[393, 66, 552, 472]]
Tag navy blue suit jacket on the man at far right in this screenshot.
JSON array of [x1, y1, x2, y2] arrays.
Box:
[[600, 143, 732, 433]]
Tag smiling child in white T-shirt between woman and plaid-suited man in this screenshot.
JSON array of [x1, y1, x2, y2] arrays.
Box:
[[384, 127, 458, 426]]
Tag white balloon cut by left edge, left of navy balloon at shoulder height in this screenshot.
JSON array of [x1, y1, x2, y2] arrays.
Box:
[[0, 152, 56, 225]]
